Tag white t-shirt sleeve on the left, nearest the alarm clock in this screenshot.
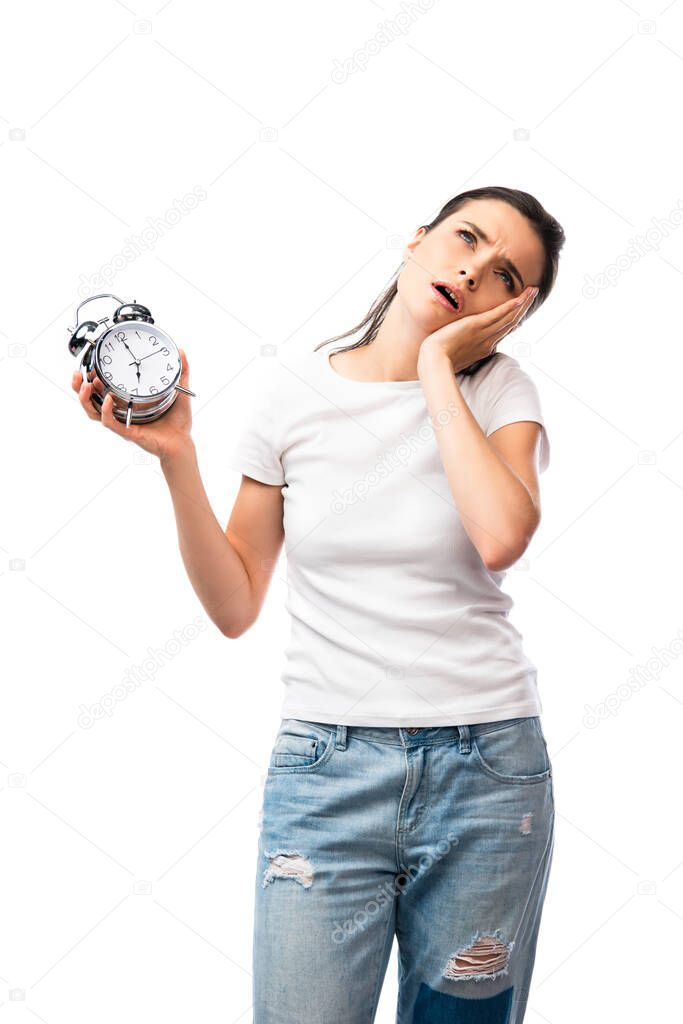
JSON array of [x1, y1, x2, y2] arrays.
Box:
[[227, 367, 285, 485]]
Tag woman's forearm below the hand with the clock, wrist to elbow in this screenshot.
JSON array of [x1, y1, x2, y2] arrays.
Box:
[[160, 442, 252, 635]]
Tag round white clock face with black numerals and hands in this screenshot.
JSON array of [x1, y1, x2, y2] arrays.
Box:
[[96, 321, 181, 398]]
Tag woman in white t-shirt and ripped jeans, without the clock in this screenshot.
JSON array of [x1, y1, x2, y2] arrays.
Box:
[[74, 187, 564, 1024]]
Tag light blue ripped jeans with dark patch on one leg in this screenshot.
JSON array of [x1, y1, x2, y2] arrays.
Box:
[[253, 717, 555, 1024]]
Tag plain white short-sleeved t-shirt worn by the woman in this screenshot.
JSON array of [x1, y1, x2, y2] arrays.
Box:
[[228, 345, 550, 727]]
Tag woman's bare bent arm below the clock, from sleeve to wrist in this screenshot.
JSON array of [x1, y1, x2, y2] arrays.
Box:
[[160, 441, 284, 639]]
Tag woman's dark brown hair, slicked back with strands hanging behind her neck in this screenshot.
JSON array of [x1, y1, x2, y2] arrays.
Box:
[[314, 185, 565, 375]]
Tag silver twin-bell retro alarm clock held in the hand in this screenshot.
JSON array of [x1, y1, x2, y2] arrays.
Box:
[[68, 293, 197, 427]]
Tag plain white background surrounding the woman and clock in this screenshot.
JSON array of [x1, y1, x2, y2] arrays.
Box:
[[0, 0, 683, 1024]]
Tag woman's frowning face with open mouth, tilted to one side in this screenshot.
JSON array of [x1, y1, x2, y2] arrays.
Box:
[[397, 200, 544, 333]]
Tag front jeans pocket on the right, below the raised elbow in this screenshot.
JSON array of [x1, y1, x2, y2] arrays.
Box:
[[472, 716, 552, 784]]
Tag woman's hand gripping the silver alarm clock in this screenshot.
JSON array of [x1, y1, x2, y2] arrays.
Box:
[[72, 349, 193, 459]]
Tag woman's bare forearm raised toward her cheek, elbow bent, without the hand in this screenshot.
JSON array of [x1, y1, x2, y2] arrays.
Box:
[[418, 349, 539, 565]]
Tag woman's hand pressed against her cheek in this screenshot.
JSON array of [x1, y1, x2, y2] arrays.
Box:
[[418, 285, 539, 374]]
